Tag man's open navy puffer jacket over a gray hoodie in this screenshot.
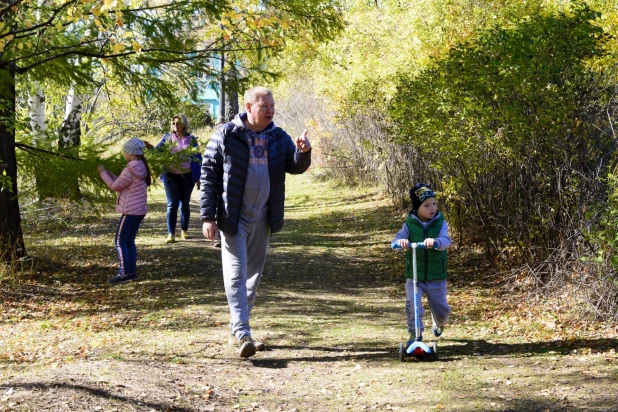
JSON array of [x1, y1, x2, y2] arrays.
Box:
[[200, 117, 311, 235]]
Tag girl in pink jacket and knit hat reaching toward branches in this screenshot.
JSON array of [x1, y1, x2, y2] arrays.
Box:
[[97, 137, 152, 284]]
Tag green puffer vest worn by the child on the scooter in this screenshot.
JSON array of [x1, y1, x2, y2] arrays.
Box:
[[406, 213, 448, 281]]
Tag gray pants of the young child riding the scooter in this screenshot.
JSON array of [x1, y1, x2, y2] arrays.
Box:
[[406, 279, 451, 333]]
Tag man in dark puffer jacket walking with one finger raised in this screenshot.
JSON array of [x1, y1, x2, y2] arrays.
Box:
[[200, 87, 311, 358]]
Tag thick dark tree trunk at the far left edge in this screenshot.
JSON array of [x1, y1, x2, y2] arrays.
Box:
[[0, 70, 26, 263]]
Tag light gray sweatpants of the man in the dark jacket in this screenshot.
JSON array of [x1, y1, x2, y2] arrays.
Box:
[[221, 216, 270, 339]]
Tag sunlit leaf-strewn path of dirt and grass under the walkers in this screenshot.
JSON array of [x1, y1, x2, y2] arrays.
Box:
[[0, 176, 618, 412]]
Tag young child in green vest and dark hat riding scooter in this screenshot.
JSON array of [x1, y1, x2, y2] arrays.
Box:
[[391, 183, 452, 348]]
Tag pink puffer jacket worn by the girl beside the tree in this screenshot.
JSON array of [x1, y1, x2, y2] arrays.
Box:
[[101, 160, 148, 216]]
